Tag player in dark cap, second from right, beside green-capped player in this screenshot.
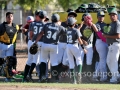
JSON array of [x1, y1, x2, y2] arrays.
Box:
[[94, 11, 108, 81]]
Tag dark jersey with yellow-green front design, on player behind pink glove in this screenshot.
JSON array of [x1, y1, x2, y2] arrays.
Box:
[[80, 24, 94, 43]]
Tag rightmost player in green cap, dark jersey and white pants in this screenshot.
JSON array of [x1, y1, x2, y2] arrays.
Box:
[[103, 8, 120, 83]]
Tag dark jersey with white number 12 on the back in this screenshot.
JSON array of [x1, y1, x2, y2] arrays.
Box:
[[67, 28, 82, 44]]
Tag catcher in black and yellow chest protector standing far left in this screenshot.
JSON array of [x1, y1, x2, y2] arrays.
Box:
[[0, 12, 19, 82]]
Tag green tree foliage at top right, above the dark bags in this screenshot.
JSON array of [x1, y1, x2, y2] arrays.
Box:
[[57, 0, 120, 11]]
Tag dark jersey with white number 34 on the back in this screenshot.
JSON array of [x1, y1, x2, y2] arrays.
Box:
[[42, 23, 66, 44]]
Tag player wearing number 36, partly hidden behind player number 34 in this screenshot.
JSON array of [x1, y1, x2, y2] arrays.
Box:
[[29, 10, 47, 79]]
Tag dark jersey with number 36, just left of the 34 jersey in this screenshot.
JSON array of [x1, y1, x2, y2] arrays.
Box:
[[29, 21, 45, 41]]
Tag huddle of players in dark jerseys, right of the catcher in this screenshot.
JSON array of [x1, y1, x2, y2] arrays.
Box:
[[0, 7, 120, 84]]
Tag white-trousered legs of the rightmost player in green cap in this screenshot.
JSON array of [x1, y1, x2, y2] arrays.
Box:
[[107, 44, 120, 83]]
